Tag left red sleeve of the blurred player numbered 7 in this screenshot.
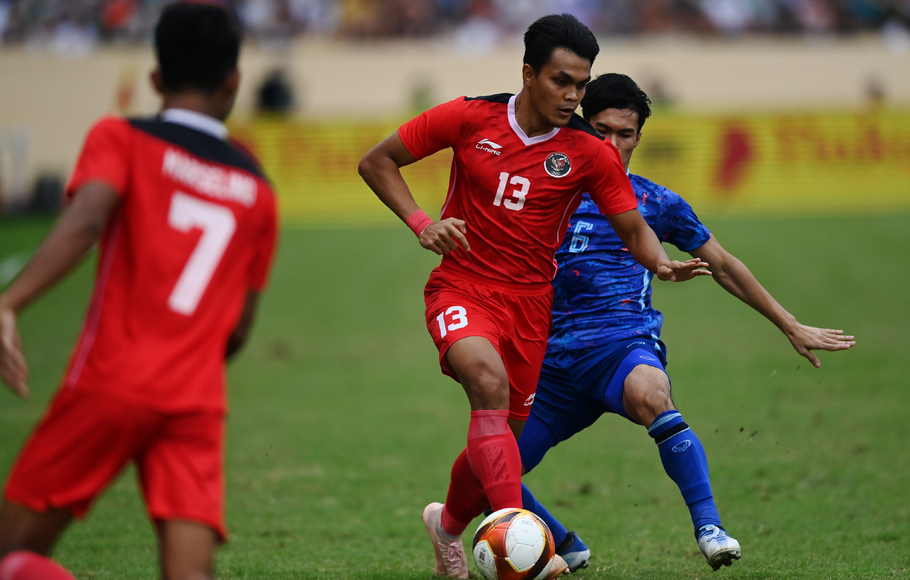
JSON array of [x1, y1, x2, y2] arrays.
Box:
[[66, 117, 131, 201]]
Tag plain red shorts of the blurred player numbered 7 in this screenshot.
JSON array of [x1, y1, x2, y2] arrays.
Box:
[[4, 389, 227, 541]]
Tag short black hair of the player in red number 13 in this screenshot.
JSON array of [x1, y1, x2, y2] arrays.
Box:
[[524, 14, 600, 72]]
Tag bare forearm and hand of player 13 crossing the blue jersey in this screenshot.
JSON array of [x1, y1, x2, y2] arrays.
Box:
[[607, 209, 711, 282]]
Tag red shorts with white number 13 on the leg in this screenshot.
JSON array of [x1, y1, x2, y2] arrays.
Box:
[[424, 270, 553, 420]]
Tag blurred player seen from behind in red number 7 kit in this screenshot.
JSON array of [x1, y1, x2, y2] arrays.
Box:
[[0, 2, 276, 580]]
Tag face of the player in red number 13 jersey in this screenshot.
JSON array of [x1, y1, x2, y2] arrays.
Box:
[[522, 48, 591, 136]]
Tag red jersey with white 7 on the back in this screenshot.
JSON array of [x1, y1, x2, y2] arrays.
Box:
[[64, 111, 277, 411]]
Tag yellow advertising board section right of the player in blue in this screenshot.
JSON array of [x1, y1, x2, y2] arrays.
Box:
[[631, 110, 910, 214]]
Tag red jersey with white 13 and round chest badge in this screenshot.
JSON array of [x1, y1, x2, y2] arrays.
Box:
[[398, 94, 637, 284]]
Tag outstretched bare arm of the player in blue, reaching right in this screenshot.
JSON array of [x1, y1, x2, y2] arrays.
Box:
[[691, 235, 856, 367]]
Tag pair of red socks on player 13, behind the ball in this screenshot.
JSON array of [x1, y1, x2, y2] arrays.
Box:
[[440, 410, 522, 536]]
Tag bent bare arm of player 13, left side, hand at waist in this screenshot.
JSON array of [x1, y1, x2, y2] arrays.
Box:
[[357, 131, 471, 255]]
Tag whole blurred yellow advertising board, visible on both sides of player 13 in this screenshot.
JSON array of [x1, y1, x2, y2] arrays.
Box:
[[232, 110, 910, 225]]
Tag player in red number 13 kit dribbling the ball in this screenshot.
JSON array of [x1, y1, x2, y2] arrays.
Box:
[[359, 14, 710, 578]]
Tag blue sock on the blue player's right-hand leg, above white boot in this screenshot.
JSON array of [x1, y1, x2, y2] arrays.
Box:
[[652, 410, 720, 530]]
